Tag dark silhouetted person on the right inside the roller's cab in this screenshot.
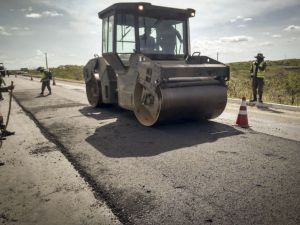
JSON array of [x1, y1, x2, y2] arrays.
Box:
[[156, 21, 183, 55]]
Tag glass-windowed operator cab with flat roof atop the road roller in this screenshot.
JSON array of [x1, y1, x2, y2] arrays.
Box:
[[98, 2, 195, 58]]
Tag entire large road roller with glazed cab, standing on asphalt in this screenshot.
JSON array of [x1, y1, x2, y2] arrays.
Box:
[[83, 2, 230, 126]]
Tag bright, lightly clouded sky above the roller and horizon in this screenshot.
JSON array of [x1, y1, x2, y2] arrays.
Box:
[[0, 0, 300, 69]]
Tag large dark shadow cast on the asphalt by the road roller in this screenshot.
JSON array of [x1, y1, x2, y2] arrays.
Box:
[[79, 106, 243, 158]]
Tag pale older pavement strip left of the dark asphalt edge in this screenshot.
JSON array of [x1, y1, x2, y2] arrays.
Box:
[[0, 84, 121, 225]]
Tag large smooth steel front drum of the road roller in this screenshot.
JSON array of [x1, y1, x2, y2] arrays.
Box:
[[134, 83, 227, 126]]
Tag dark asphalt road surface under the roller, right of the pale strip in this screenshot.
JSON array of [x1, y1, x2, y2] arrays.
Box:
[[6, 78, 300, 224]]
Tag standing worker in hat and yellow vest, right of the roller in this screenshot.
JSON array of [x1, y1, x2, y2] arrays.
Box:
[[250, 53, 267, 103]]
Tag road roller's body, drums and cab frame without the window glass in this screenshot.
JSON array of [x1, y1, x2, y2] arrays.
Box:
[[84, 2, 230, 126]]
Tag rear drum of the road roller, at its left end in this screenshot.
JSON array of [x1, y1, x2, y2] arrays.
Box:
[[85, 76, 103, 107]]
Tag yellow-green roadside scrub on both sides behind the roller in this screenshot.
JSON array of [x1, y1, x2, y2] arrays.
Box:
[[25, 59, 300, 106]]
